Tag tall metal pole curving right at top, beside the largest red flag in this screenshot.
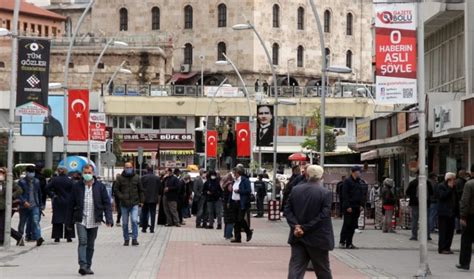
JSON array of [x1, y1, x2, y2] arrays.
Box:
[[63, 0, 95, 166]]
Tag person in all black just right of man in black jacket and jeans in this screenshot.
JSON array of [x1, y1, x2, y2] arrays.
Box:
[[140, 167, 162, 233]]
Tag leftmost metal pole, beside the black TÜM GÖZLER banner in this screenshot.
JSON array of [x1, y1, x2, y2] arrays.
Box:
[[0, 0, 20, 249]]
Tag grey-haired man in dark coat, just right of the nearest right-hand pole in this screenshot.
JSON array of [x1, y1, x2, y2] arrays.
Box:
[[438, 172, 459, 255]]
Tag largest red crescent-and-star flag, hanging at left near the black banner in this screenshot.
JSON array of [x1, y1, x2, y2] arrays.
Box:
[[68, 89, 89, 141]]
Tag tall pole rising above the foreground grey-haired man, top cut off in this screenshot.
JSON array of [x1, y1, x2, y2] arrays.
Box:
[[309, 0, 327, 168]]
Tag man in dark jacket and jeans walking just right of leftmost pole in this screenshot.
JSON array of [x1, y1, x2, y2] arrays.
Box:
[[18, 166, 44, 246]]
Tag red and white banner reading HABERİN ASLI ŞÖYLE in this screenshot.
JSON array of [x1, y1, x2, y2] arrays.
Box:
[[375, 3, 418, 104]]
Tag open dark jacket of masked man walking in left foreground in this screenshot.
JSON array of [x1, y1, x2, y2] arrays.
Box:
[[65, 180, 114, 228]]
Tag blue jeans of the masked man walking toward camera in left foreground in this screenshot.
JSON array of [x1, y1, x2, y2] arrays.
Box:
[[76, 224, 99, 268]]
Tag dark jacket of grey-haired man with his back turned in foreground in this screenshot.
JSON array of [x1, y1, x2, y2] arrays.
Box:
[[285, 183, 334, 253]]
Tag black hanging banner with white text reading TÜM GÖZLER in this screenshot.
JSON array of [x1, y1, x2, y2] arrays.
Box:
[[15, 39, 50, 117]]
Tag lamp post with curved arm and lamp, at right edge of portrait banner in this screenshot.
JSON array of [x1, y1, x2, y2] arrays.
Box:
[[232, 21, 278, 200]]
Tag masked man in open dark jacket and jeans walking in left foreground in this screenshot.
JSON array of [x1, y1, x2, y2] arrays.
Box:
[[65, 165, 113, 275]]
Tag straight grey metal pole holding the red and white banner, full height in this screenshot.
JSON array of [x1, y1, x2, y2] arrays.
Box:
[[416, 1, 431, 277]]
